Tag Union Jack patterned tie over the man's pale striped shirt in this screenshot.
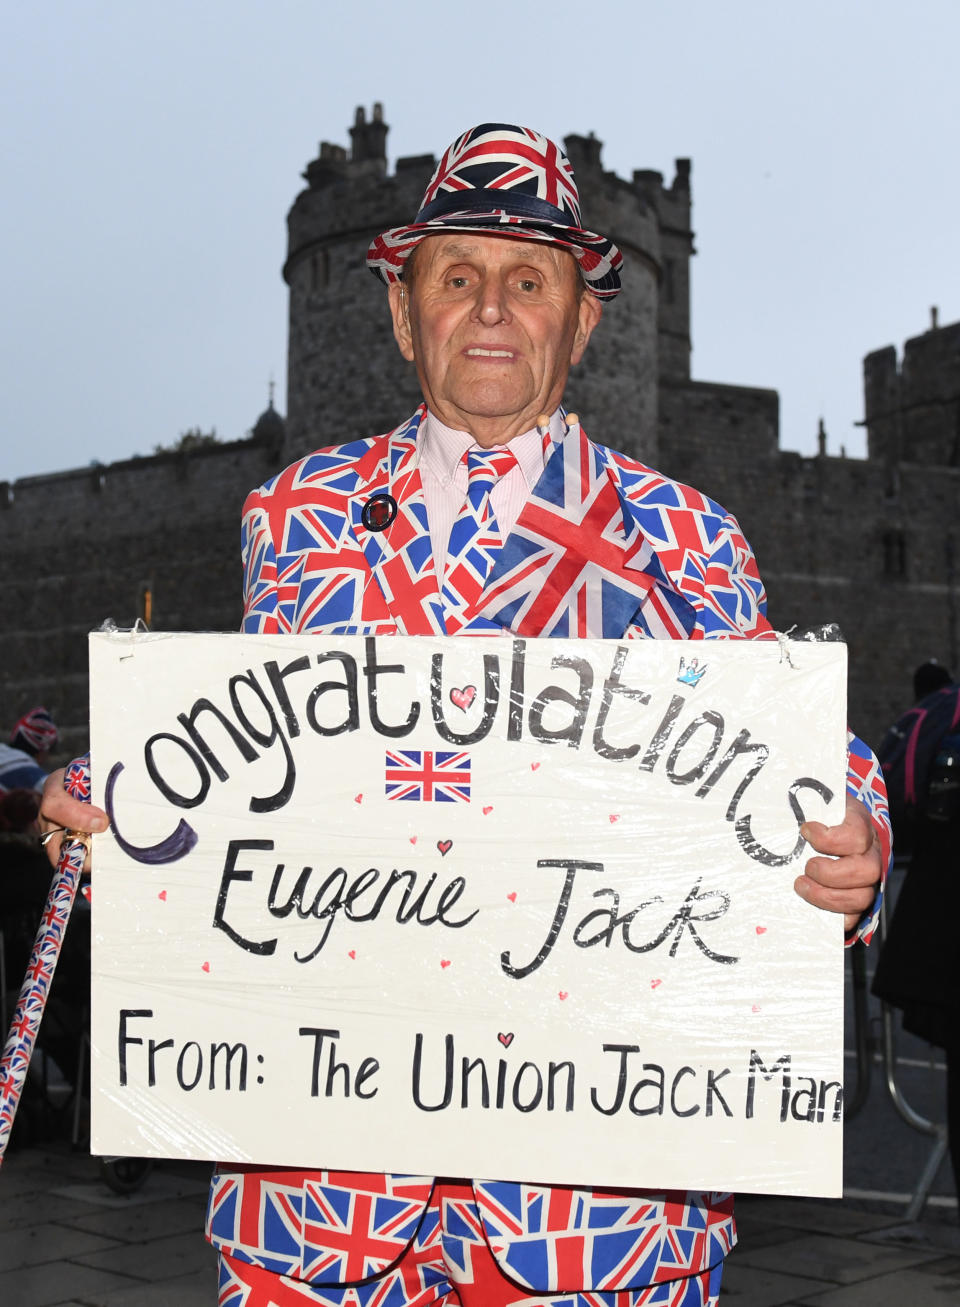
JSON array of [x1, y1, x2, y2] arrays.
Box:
[[443, 448, 517, 635]]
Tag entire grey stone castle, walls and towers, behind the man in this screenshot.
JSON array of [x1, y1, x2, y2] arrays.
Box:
[[0, 114, 960, 754]]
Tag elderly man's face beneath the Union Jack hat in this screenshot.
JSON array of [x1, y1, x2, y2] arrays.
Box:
[[389, 233, 601, 447]]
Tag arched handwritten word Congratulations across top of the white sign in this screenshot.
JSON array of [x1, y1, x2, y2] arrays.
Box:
[[104, 637, 833, 867]]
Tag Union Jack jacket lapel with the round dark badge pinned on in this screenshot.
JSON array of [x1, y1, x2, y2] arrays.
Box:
[[350, 405, 445, 635]]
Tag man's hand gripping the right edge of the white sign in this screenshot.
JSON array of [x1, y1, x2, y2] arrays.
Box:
[[794, 795, 883, 935]]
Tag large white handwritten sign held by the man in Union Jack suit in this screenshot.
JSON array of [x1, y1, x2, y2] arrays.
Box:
[[90, 634, 846, 1195]]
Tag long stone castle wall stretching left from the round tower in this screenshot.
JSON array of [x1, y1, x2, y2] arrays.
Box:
[[0, 440, 280, 757]]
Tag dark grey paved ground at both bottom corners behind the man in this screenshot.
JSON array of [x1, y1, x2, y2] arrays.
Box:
[[0, 874, 960, 1307]]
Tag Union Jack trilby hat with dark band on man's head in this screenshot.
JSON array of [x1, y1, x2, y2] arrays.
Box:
[[367, 123, 623, 299]]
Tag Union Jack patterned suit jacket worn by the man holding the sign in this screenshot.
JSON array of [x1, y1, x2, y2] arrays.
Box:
[[208, 408, 889, 1293]]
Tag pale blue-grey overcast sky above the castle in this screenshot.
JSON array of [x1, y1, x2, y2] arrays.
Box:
[[0, 0, 960, 480]]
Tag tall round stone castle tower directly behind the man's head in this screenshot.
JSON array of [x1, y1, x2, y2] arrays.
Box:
[[283, 105, 692, 461]]
